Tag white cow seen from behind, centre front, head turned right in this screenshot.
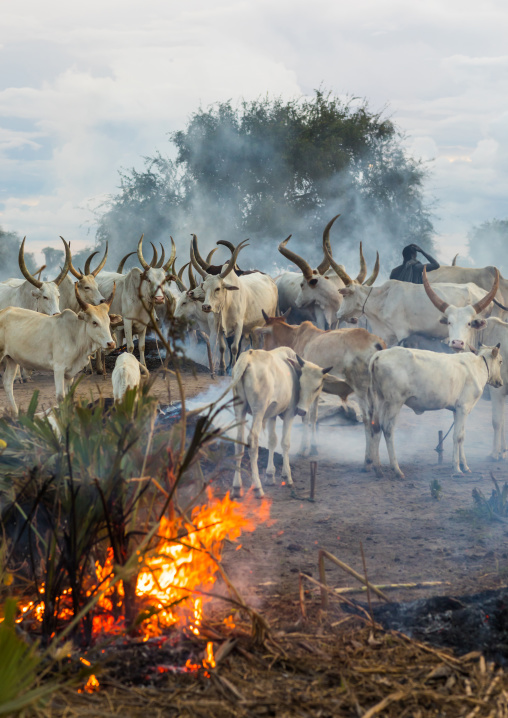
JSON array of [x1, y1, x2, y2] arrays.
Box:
[[225, 347, 343, 497]]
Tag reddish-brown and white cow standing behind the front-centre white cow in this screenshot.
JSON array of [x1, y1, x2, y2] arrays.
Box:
[[258, 314, 386, 466]]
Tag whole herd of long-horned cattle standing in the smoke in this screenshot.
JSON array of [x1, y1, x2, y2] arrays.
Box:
[[0, 222, 508, 496]]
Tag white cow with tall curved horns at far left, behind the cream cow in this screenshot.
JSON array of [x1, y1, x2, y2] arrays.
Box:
[[0, 238, 71, 315]]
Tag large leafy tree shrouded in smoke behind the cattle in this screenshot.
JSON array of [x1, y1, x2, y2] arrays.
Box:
[[97, 91, 433, 269]]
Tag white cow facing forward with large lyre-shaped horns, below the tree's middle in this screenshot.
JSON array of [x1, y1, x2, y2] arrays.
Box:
[[191, 240, 277, 374]]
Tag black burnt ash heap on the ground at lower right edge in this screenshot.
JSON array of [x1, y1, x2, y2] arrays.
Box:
[[373, 588, 508, 667]]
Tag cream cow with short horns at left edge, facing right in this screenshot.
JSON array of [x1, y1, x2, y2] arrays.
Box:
[[0, 288, 120, 415]]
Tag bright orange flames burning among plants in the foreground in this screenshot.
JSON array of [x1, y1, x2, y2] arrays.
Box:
[[13, 488, 270, 648]]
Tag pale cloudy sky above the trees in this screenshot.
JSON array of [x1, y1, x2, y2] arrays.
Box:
[[0, 0, 508, 261]]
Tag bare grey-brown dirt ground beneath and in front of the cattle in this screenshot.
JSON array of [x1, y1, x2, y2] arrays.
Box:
[[4, 358, 508, 607]]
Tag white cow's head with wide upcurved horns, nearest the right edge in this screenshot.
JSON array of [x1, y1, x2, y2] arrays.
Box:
[[423, 267, 499, 352]]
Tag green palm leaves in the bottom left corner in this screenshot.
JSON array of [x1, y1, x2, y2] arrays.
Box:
[[0, 599, 58, 716]]
